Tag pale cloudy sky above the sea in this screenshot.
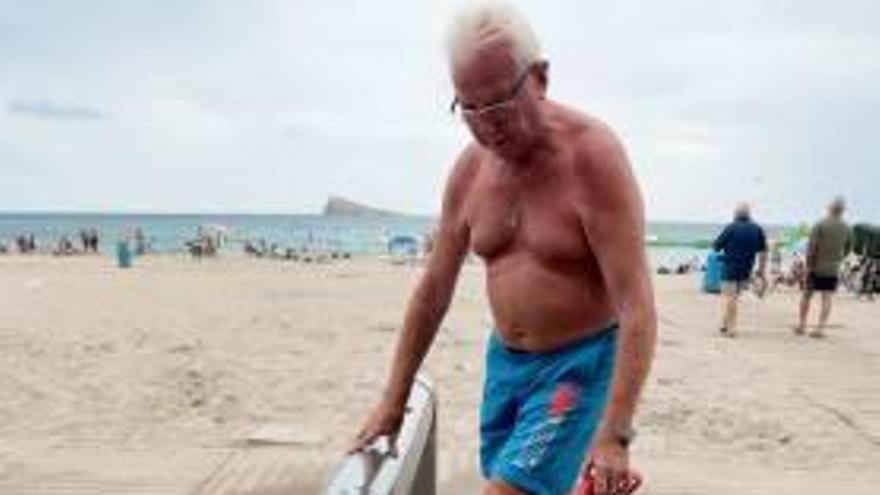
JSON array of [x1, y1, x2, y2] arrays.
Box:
[[0, 0, 880, 222]]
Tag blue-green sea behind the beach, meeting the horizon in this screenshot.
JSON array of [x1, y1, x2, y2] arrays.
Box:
[[0, 212, 792, 263]]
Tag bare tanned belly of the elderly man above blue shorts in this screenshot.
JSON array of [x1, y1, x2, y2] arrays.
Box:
[[486, 262, 616, 352]]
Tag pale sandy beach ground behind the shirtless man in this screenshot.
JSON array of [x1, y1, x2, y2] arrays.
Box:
[[0, 255, 880, 495]]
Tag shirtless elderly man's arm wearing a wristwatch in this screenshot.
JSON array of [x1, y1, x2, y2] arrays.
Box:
[[579, 129, 657, 454]]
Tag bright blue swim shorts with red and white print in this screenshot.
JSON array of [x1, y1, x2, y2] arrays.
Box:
[[480, 325, 617, 495]]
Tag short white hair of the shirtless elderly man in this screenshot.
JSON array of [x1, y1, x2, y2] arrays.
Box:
[[446, 0, 541, 70]]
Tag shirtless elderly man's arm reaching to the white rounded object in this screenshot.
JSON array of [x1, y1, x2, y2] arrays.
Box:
[[350, 149, 477, 451]]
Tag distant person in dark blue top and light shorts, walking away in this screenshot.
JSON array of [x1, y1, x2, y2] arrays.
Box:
[[712, 203, 767, 337]]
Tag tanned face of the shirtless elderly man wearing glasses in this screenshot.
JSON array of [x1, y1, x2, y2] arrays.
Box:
[[453, 37, 539, 158]]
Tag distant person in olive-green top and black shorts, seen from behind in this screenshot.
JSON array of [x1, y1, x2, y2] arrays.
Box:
[[794, 198, 852, 338]]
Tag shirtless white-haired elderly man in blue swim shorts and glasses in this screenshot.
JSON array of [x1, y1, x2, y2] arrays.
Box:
[[352, 3, 656, 495]]
